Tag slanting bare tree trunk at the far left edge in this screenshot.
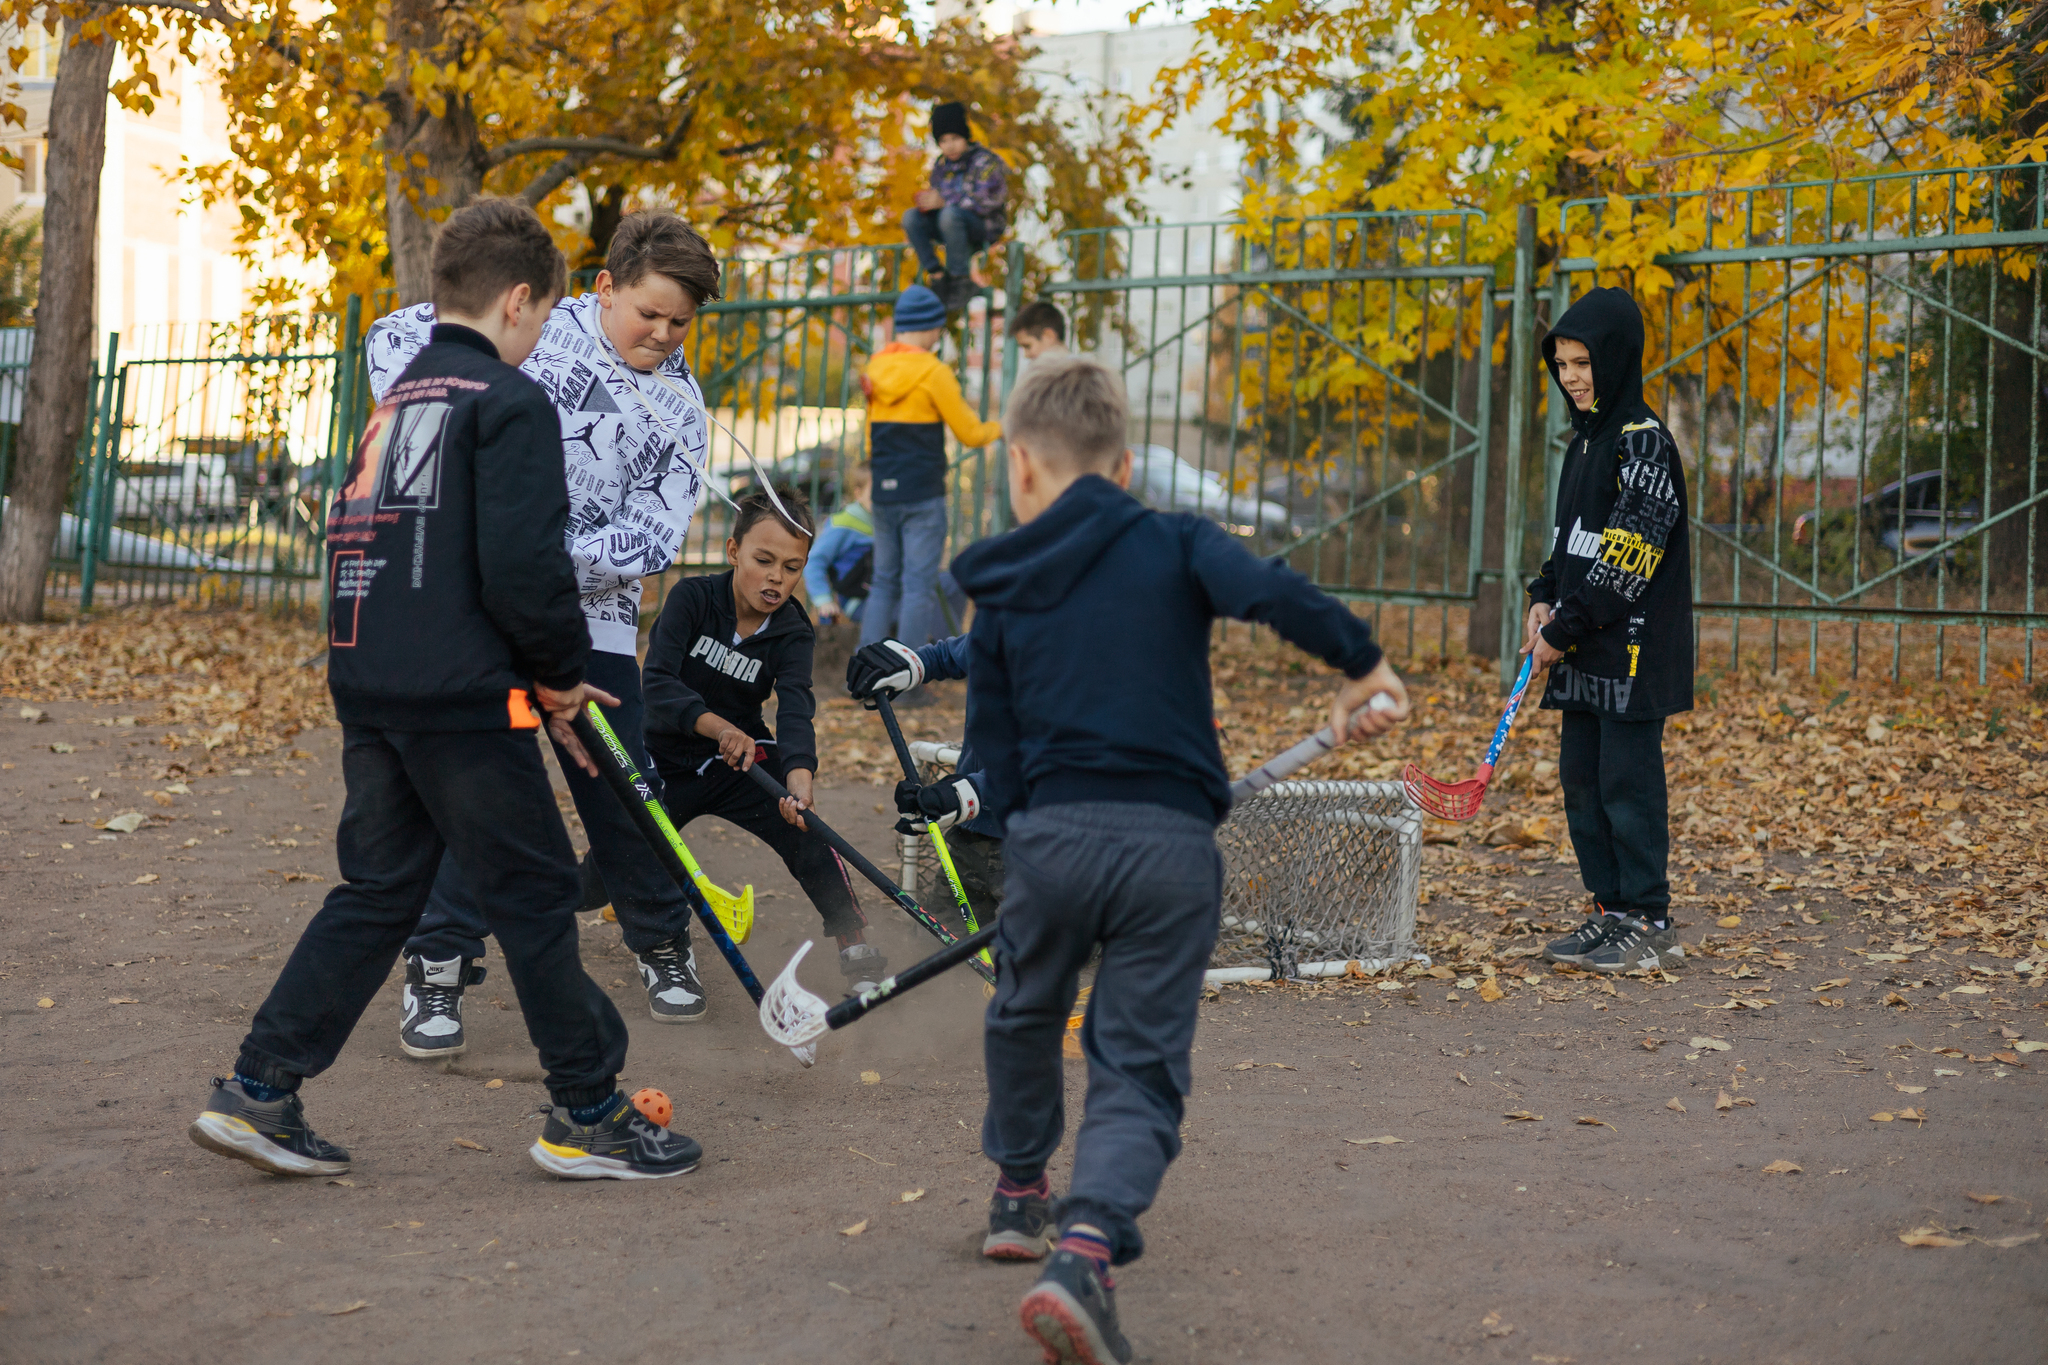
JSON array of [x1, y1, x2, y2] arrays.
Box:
[[0, 10, 115, 620]]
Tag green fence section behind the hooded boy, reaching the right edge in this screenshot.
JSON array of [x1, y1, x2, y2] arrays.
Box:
[[1528, 166, 2048, 681]]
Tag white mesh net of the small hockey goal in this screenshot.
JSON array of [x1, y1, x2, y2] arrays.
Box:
[[901, 740, 1421, 980]]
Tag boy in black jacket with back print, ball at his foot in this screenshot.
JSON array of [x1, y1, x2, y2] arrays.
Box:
[[190, 199, 700, 1179]]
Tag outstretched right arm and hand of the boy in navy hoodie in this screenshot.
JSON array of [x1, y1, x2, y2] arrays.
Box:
[[1188, 518, 1409, 743]]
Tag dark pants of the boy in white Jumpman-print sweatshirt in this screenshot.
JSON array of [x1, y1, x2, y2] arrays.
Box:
[[406, 651, 690, 962]]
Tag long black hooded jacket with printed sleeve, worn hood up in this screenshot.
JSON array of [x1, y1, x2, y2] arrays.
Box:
[[1528, 289, 1692, 720]]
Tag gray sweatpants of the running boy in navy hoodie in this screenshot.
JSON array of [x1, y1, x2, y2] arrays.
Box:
[[981, 802, 1223, 1265]]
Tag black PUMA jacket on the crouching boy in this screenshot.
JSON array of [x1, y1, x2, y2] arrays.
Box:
[[641, 571, 817, 774]]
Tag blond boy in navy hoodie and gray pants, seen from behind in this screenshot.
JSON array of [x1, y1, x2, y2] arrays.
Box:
[[954, 358, 1407, 1365]]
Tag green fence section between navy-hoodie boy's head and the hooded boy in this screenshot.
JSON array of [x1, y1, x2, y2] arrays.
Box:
[[1044, 211, 1497, 653]]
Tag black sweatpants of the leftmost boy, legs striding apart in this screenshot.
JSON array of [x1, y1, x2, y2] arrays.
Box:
[[236, 726, 627, 1105]]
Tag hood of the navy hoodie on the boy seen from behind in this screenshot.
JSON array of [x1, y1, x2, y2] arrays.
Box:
[[952, 475, 1145, 612]]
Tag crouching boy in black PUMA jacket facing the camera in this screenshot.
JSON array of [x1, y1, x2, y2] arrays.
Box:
[[641, 489, 889, 990]]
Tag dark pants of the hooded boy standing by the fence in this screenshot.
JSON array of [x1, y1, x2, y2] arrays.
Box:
[[1556, 710, 1671, 919]]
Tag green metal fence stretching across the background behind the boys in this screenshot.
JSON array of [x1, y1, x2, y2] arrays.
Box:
[[28, 166, 2048, 679]]
